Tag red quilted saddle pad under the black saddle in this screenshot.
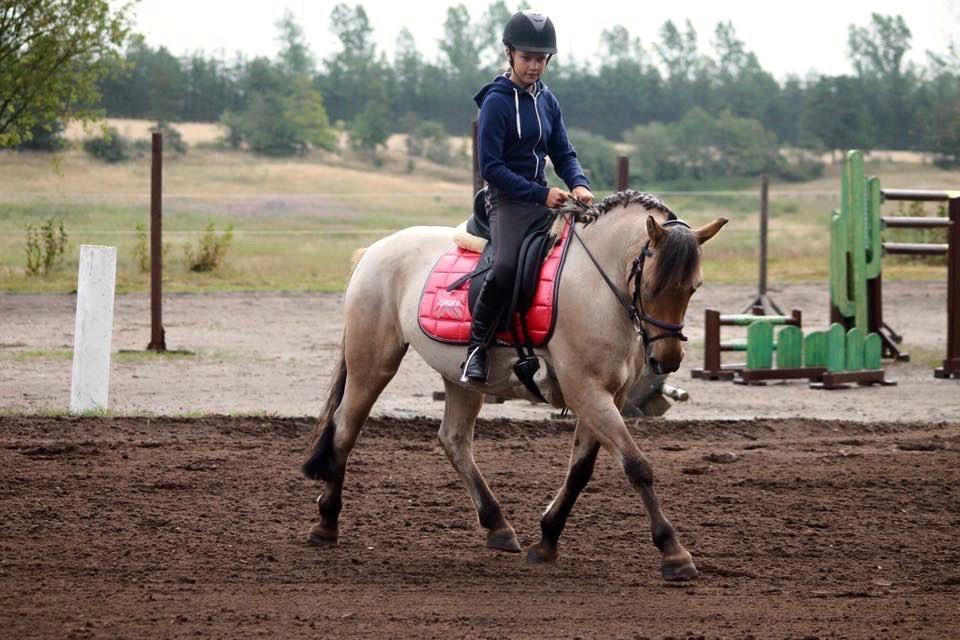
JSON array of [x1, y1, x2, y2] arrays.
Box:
[[420, 223, 570, 346]]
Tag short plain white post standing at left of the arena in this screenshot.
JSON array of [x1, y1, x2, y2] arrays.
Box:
[[70, 244, 117, 413]]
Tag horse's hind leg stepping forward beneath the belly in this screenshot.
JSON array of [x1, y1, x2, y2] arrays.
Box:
[[437, 379, 520, 553]]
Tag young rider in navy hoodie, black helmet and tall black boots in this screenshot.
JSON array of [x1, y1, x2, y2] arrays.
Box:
[[460, 11, 593, 383]]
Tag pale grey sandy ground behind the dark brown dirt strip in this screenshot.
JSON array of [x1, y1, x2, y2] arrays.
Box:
[[0, 282, 960, 421]]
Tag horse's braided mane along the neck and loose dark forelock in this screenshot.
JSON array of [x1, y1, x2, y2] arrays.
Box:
[[577, 189, 700, 295]]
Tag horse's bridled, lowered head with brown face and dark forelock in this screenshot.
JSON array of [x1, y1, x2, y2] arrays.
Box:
[[631, 215, 727, 374]]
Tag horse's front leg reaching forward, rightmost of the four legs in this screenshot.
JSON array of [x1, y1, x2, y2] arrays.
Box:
[[571, 389, 698, 580]]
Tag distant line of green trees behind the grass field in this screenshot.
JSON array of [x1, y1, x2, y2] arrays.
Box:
[[92, 1, 960, 171]]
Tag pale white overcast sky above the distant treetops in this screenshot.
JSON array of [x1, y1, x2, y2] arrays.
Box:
[[134, 0, 960, 80]]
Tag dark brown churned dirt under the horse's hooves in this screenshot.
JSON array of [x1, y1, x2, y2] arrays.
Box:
[[0, 416, 960, 640]]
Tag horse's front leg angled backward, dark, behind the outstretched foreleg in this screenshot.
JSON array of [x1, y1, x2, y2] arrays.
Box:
[[527, 421, 600, 564]]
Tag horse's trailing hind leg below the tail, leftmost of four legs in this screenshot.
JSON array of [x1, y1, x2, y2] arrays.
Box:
[[303, 326, 407, 544]]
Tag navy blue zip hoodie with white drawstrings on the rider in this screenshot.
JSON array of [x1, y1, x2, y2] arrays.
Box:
[[473, 76, 590, 204]]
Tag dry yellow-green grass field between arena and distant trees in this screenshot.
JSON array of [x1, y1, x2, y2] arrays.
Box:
[[0, 128, 960, 292]]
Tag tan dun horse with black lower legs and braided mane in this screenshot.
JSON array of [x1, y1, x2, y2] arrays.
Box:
[[302, 191, 727, 580]]
